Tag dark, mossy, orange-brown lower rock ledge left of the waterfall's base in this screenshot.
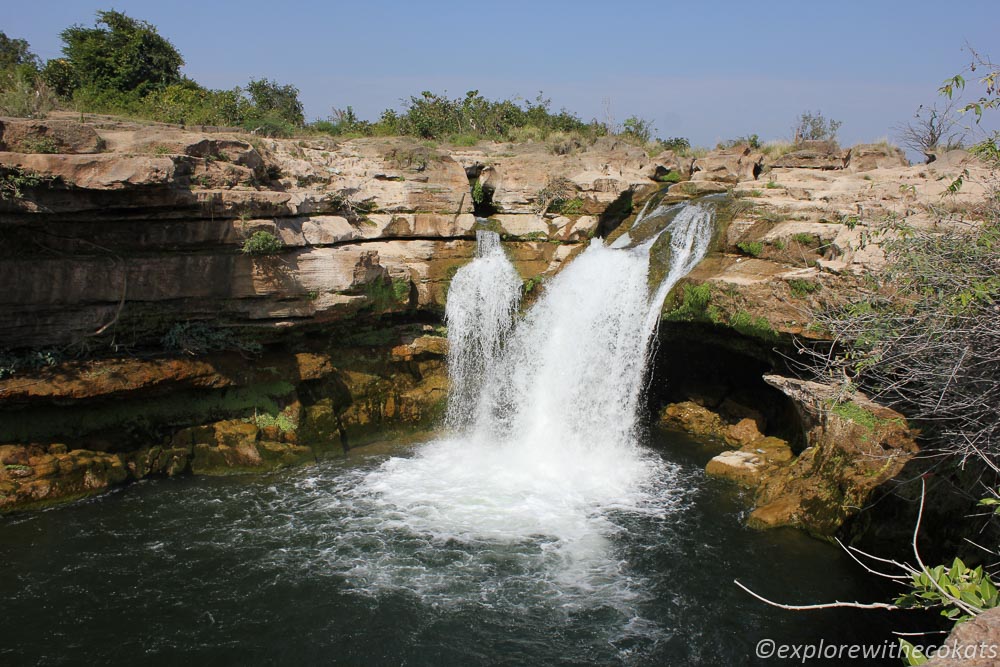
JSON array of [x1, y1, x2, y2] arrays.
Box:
[[0, 326, 447, 512]]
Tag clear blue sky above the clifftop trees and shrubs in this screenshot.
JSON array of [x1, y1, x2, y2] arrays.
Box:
[[7, 0, 1000, 145]]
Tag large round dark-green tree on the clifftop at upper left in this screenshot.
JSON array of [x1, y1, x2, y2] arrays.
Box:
[[60, 11, 184, 96]]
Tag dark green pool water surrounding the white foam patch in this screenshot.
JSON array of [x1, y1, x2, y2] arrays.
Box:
[[0, 431, 900, 666]]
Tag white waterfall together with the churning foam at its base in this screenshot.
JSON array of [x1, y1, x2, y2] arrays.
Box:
[[348, 205, 712, 619]]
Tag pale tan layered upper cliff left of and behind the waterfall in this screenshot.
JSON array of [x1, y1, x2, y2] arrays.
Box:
[[0, 114, 676, 348]]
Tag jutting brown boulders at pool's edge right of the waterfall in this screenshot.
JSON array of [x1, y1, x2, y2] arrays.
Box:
[[660, 375, 918, 535]]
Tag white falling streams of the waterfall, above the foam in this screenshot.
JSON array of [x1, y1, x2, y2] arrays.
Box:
[[447, 205, 712, 458]]
